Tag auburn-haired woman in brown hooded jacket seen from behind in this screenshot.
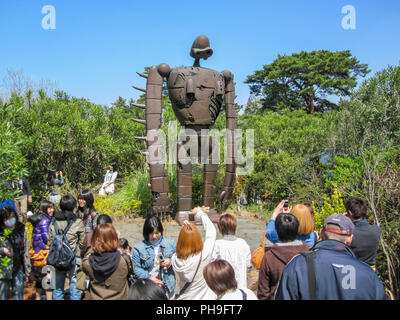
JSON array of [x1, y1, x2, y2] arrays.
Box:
[[82, 223, 129, 300]]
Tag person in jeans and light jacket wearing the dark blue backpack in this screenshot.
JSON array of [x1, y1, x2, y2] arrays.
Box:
[[48, 194, 85, 300]]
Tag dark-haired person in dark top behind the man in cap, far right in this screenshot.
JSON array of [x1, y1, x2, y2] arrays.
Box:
[[344, 197, 381, 270]]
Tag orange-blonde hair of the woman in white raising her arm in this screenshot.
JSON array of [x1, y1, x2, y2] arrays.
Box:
[[176, 224, 203, 260]]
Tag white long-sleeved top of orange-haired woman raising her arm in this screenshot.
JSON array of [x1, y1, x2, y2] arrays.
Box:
[[171, 209, 217, 300]]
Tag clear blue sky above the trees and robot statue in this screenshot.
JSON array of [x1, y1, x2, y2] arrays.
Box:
[[0, 0, 400, 105]]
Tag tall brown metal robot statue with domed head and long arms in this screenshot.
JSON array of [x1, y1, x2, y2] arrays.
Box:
[[133, 35, 237, 225]]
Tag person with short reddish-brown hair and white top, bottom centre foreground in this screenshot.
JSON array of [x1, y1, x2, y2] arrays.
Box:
[[203, 259, 257, 300]]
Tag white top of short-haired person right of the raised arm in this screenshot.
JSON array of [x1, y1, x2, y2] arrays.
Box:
[[212, 235, 251, 288]]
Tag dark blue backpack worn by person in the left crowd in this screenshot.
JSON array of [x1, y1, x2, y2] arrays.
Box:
[[47, 219, 75, 271]]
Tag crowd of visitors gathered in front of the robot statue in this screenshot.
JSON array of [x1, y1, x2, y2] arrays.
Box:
[[0, 168, 386, 300]]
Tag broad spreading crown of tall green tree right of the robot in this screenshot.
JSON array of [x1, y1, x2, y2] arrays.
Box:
[[245, 50, 369, 114]]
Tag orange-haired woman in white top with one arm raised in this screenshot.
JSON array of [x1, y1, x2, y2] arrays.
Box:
[[171, 207, 217, 300]]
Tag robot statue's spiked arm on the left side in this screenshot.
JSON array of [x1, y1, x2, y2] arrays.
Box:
[[133, 63, 170, 213]]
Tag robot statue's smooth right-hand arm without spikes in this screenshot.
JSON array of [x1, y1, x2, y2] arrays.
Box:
[[219, 70, 237, 211]]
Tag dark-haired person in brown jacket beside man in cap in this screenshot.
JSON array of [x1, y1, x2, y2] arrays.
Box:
[[257, 213, 310, 300]]
